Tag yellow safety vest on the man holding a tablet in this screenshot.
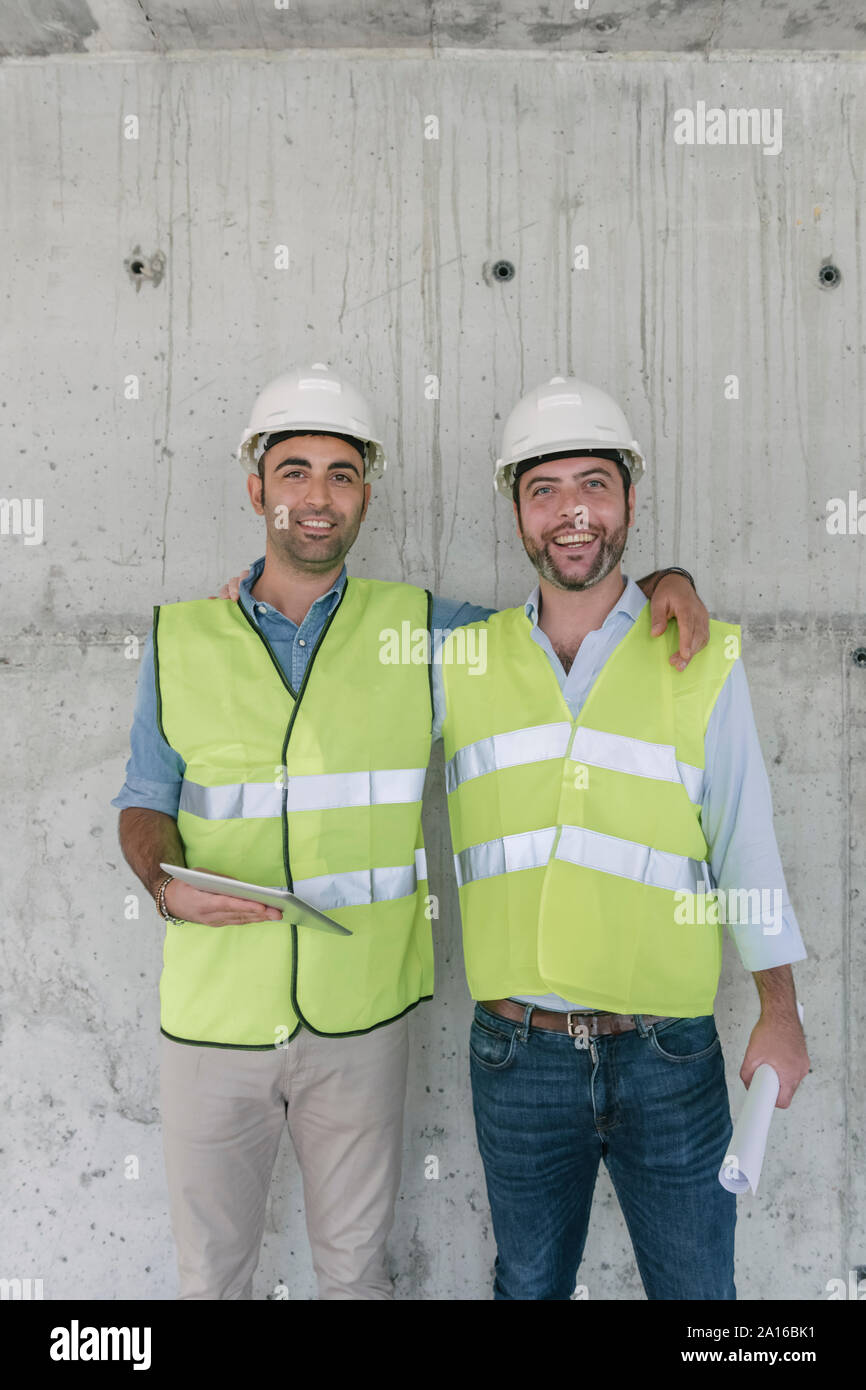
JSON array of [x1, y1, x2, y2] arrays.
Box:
[[154, 578, 434, 1048]]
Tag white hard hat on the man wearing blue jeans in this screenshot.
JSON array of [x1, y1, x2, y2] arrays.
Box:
[[493, 377, 645, 498]]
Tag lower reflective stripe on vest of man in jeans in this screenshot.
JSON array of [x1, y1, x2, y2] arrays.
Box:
[[455, 826, 710, 892]]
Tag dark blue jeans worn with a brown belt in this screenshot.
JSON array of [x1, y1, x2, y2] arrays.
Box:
[[470, 1004, 737, 1300]]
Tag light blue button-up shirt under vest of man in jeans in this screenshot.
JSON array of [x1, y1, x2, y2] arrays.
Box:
[[434, 578, 806, 1012]]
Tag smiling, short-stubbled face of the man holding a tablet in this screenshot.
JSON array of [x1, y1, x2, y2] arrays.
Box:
[[246, 435, 370, 574]]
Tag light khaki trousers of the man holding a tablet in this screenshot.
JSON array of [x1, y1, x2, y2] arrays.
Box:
[[160, 1017, 409, 1298]]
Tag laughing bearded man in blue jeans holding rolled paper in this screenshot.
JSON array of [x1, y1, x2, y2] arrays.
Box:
[[436, 378, 809, 1300]]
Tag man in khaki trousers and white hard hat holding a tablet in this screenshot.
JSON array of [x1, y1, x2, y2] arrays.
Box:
[[114, 364, 705, 1300]]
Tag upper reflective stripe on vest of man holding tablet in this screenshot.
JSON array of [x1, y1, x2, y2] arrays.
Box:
[[179, 767, 427, 820]]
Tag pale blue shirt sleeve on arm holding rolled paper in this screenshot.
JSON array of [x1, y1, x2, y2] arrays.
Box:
[[701, 660, 806, 970]]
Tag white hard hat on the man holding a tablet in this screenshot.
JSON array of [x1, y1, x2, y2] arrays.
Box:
[[238, 361, 388, 481]]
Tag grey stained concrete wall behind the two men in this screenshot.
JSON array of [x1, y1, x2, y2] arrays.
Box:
[[0, 53, 866, 1300]]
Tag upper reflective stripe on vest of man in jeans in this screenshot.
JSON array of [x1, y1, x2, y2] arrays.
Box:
[[445, 723, 703, 805]]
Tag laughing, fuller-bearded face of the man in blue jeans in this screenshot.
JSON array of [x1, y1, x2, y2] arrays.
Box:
[[514, 457, 634, 589]]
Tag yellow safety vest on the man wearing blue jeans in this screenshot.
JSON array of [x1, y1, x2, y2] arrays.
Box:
[[442, 605, 740, 1017]]
